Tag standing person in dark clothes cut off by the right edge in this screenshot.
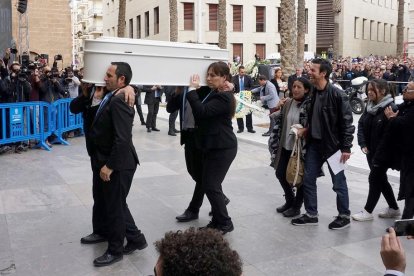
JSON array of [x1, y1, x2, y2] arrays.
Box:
[[385, 82, 414, 219]]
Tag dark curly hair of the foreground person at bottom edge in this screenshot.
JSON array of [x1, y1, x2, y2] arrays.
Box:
[[155, 227, 243, 276]]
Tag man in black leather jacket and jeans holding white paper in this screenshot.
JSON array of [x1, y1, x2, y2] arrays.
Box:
[[292, 59, 355, 230]]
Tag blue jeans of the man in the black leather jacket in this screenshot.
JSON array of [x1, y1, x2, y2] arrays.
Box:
[[303, 141, 351, 216]]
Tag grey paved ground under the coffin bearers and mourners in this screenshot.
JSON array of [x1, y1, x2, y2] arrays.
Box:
[[0, 106, 414, 276]]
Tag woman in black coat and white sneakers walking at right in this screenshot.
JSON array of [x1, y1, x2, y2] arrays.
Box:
[[352, 79, 401, 221]]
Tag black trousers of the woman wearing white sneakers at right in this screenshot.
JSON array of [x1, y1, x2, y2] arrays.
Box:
[[364, 166, 398, 213]]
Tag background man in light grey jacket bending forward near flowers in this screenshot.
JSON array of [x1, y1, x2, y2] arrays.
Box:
[[252, 75, 279, 136]]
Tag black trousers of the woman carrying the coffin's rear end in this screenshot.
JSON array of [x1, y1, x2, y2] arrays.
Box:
[[201, 147, 237, 226]]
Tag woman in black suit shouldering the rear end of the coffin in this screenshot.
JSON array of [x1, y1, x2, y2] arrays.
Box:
[[187, 62, 237, 234]]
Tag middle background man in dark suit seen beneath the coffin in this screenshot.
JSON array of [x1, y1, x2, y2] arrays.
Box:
[[142, 85, 162, 132]]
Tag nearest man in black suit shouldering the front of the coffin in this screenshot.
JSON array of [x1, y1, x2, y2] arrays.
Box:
[[89, 62, 147, 266]]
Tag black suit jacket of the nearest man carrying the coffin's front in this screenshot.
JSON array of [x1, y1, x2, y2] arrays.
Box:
[[90, 93, 139, 171]]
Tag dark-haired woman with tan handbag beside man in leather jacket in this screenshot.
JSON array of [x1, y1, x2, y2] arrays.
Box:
[[269, 77, 311, 217]]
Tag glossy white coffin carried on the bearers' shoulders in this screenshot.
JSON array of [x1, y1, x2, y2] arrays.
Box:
[[83, 37, 229, 86]]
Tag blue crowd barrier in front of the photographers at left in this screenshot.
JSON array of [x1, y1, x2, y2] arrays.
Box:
[[0, 99, 83, 151]]
